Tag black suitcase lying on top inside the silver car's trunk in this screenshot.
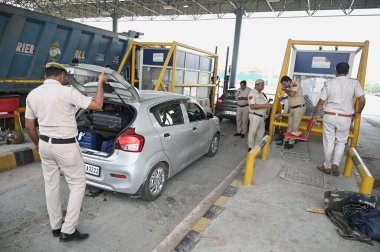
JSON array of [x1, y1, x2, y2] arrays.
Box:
[[92, 111, 128, 133]]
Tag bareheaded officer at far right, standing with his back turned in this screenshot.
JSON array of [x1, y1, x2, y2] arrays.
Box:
[[314, 62, 365, 176]]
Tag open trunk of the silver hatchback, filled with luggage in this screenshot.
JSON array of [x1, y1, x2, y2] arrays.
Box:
[[76, 101, 136, 157]]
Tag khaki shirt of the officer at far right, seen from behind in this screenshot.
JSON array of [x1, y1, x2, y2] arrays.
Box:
[[321, 76, 364, 115]]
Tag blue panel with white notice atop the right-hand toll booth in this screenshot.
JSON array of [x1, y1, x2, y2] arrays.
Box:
[[294, 51, 350, 76]]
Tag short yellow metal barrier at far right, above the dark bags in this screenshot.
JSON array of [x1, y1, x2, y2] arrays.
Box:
[[343, 147, 375, 195]]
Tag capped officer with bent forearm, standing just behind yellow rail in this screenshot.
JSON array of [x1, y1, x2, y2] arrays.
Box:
[[248, 79, 273, 151]]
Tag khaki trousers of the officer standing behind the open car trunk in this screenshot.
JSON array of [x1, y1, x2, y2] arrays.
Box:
[[39, 140, 86, 234]]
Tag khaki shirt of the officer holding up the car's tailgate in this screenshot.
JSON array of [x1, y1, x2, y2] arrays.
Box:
[[25, 79, 91, 139]]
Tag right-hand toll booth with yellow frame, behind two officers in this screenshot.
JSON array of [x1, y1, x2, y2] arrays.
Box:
[[263, 40, 369, 173]]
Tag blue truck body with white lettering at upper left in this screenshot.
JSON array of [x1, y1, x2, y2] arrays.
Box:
[[0, 4, 131, 102]]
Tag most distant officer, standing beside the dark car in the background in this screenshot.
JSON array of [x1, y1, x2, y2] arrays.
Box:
[[234, 80, 252, 138]]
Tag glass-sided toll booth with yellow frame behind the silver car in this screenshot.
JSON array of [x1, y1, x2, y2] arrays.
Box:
[[119, 41, 218, 108]]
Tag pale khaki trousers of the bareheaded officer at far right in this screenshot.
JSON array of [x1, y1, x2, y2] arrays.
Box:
[[323, 114, 351, 168]]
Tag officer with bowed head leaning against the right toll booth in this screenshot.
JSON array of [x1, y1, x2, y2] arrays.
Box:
[[280, 76, 306, 149]]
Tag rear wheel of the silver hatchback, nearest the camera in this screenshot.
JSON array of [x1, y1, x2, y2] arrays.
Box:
[[141, 163, 167, 201]]
